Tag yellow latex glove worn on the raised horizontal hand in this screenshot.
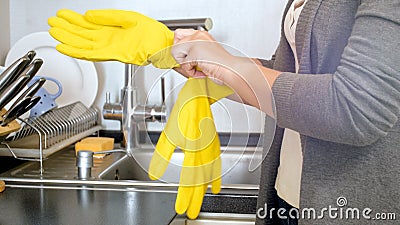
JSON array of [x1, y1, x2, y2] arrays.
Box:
[[48, 9, 178, 69]]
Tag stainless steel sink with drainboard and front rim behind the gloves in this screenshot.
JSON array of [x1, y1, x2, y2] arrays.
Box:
[[0, 145, 261, 194]]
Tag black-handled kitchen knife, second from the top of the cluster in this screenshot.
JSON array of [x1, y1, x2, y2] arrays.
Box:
[[0, 59, 43, 109]]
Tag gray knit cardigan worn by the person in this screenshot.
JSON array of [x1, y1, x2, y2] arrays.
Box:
[[256, 0, 400, 225]]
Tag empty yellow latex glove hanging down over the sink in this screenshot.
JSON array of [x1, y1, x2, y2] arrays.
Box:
[[149, 78, 233, 219]]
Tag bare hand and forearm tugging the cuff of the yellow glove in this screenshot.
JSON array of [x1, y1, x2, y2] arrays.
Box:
[[171, 29, 280, 117]]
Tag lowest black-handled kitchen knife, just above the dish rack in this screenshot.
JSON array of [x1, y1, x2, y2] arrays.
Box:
[[0, 96, 41, 126]]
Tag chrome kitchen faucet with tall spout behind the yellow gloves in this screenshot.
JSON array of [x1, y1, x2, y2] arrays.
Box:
[[103, 18, 212, 156]]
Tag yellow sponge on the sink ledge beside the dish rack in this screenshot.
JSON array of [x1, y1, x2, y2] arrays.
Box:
[[75, 137, 114, 157]]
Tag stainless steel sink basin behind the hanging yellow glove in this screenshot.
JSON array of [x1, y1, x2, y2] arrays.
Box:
[[99, 147, 261, 185]]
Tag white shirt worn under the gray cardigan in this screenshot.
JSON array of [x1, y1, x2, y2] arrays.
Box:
[[275, 0, 307, 208]]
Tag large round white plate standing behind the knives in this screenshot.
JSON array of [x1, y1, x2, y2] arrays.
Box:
[[5, 32, 98, 107]]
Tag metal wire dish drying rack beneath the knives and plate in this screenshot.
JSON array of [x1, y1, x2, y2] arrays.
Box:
[[0, 102, 101, 174]]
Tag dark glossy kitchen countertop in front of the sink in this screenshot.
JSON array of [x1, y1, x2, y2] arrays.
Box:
[[0, 184, 256, 225]]
